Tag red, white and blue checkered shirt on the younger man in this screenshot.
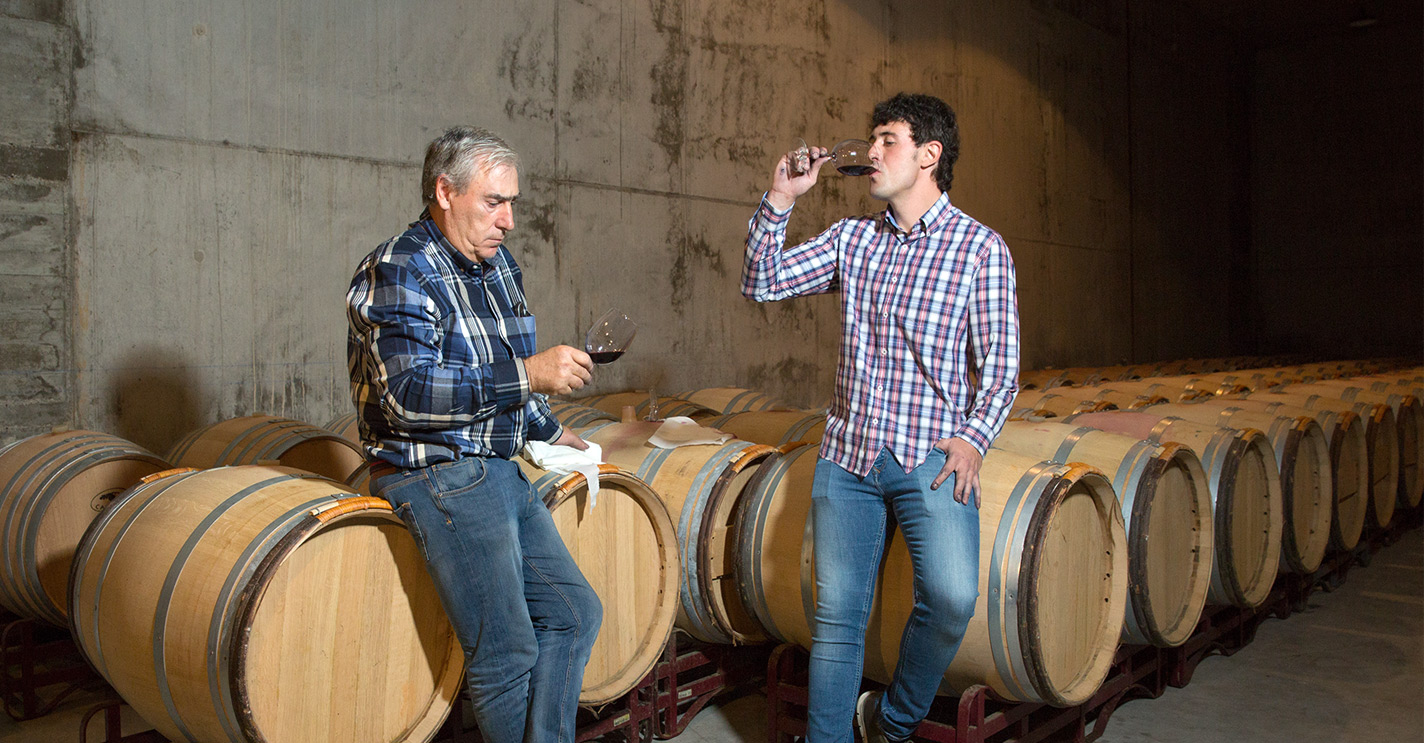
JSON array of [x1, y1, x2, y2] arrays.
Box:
[[742, 194, 1018, 477]]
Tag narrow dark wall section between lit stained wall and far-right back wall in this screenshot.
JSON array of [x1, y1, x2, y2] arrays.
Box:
[[1128, 3, 1252, 362]]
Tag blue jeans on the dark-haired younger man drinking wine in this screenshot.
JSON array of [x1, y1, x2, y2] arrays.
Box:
[[806, 448, 978, 743]]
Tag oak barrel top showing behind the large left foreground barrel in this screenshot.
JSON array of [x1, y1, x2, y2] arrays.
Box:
[[164, 416, 366, 481]]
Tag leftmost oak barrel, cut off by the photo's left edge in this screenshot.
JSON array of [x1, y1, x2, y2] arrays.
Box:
[[0, 431, 168, 626]]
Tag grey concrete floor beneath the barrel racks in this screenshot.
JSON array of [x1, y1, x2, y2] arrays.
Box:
[[0, 529, 1424, 743]]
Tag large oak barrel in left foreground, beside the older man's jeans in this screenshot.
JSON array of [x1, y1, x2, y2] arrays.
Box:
[[70, 465, 464, 743]]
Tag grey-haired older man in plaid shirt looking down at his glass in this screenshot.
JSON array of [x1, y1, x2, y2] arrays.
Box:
[[346, 127, 602, 743]]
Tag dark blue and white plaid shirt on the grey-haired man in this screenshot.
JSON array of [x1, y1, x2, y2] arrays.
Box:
[[346, 212, 562, 468]]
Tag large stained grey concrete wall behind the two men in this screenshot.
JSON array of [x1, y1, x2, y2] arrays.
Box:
[[0, 0, 1355, 450]]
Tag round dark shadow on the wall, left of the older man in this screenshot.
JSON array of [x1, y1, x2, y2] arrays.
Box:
[[108, 346, 206, 455]]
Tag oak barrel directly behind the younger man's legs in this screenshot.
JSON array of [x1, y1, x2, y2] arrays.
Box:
[[738, 446, 1128, 706]]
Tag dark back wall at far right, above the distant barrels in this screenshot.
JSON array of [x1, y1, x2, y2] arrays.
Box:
[[1250, 13, 1424, 359]]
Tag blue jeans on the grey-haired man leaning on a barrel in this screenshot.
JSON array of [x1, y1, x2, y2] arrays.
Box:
[[372, 457, 602, 743]]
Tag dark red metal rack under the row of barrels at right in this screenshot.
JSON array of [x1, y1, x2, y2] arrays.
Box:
[[766, 508, 1424, 743]]
